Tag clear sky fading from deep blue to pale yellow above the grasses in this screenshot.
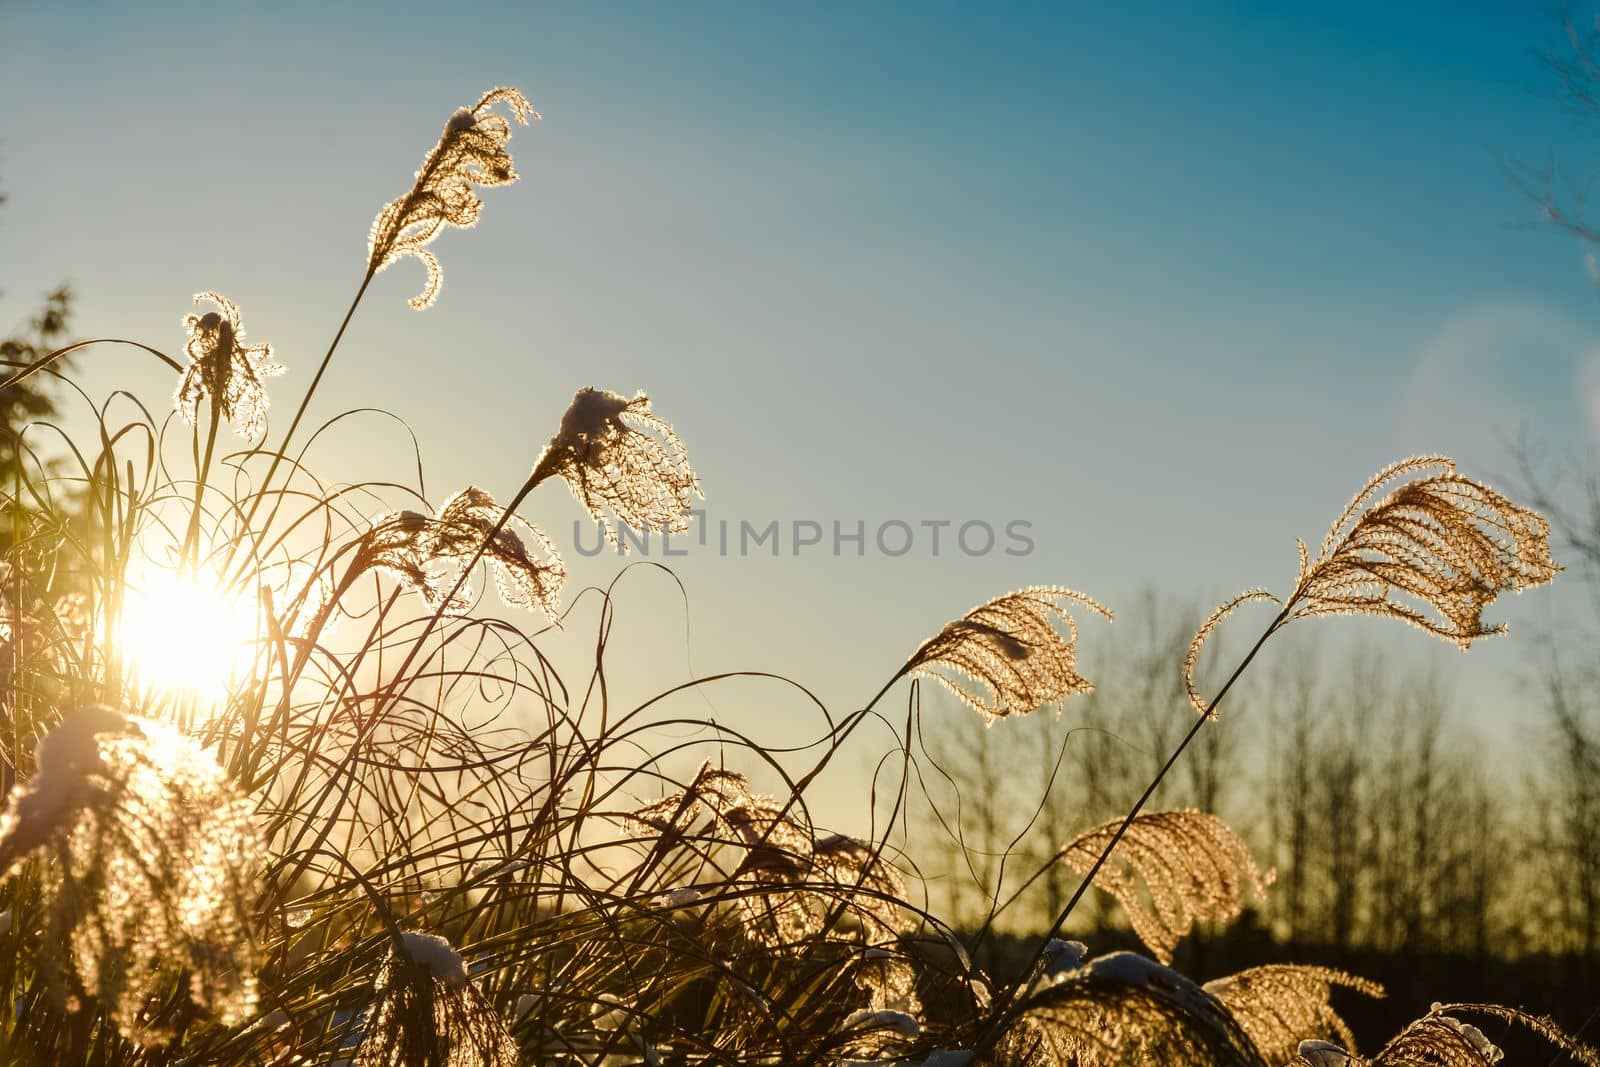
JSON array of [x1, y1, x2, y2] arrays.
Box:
[[0, 0, 1600, 819]]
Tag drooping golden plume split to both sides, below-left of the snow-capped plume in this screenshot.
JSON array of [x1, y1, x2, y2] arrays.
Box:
[[352, 485, 566, 619]]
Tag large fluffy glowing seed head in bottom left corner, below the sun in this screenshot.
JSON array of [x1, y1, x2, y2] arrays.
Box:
[[0, 707, 264, 1045]]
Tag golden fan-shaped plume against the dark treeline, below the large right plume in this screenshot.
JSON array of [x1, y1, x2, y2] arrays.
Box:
[[1059, 811, 1272, 963]]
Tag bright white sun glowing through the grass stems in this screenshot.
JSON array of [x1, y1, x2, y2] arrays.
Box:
[[122, 571, 256, 696]]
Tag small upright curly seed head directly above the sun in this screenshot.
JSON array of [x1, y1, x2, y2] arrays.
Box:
[[173, 293, 283, 442]]
